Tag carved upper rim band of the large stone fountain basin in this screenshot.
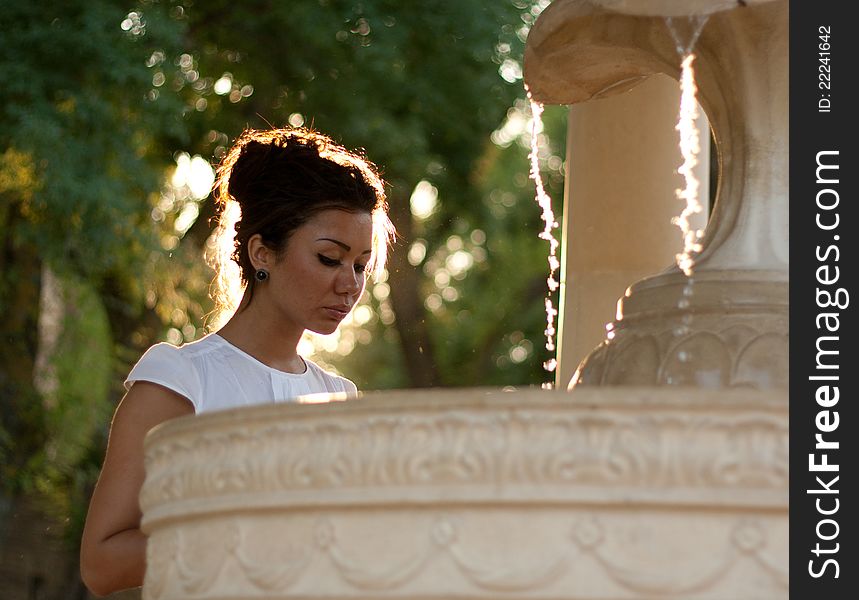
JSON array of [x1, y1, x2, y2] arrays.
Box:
[[140, 386, 789, 533]]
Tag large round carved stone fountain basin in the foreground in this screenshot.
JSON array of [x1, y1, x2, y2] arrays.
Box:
[[140, 387, 788, 600]]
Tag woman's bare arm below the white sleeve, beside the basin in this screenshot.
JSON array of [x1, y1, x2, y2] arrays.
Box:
[[81, 381, 194, 596]]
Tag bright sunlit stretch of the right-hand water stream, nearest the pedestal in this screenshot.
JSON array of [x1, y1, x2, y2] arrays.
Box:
[[671, 54, 703, 277]]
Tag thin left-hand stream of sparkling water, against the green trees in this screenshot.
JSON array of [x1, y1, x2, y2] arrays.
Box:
[[525, 86, 561, 389]]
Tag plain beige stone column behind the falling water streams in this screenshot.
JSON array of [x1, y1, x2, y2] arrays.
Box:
[[556, 76, 710, 389]]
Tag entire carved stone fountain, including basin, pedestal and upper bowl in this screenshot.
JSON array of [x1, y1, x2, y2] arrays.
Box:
[[140, 0, 788, 600]]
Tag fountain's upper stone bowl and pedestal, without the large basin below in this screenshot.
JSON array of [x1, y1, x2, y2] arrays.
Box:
[[525, 0, 788, 388]]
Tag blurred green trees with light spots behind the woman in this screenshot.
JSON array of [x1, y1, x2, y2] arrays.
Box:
[[0, 0, 566, 600]]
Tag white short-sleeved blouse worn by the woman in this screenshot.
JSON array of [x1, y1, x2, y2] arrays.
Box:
[[125, 333, 357, 414]]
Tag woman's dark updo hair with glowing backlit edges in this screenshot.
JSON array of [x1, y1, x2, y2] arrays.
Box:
[[210, 128, 394, 324]]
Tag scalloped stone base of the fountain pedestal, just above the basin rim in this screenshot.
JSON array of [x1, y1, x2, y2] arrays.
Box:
[[570, 275, 789, 389]]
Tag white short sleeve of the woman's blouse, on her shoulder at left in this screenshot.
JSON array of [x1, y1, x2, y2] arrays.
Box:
[[125, 343, 202, 412]]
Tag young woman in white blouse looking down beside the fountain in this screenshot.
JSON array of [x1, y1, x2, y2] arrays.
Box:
[[81, 129, 393, 595]]
